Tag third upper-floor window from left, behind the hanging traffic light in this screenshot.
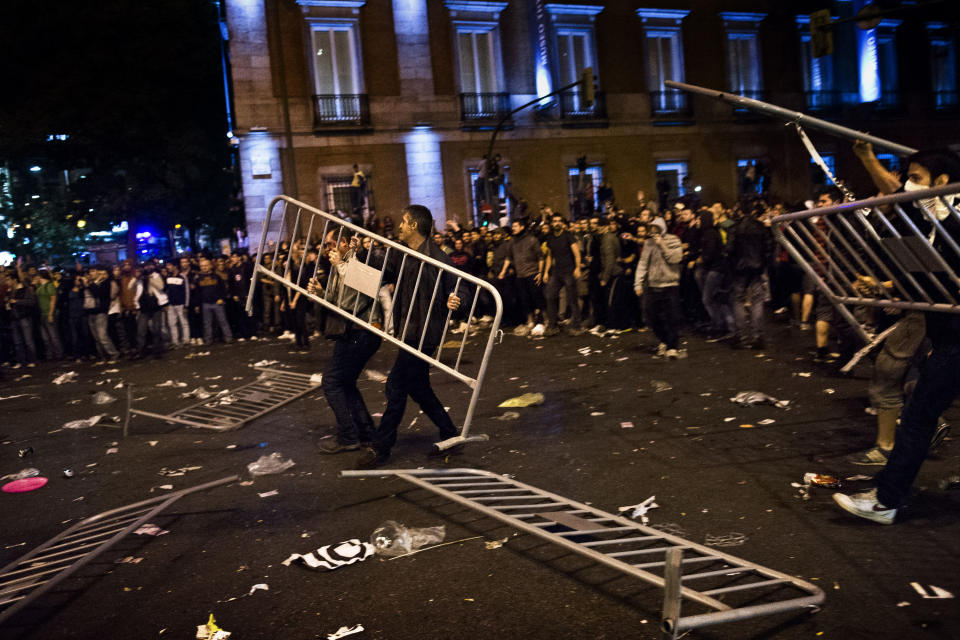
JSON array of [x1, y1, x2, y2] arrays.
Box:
[[545, 4, 603, 118]]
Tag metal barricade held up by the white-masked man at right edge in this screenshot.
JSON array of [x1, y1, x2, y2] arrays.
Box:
[[772, 182, 960, 342]]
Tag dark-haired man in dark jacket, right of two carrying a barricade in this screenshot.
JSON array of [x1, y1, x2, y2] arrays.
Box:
[[357, 204, 460, 469]]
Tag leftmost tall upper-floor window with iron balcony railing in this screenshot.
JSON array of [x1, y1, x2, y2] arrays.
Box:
[[297, 0, 370, 129]]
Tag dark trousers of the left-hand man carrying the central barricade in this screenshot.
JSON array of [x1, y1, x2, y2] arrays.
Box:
[[321, 328, 382, 445]]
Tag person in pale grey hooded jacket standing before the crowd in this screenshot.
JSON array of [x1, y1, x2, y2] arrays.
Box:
[[633, 218, 687, 360]]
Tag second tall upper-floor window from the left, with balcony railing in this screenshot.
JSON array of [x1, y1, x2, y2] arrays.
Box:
[[446, 1, 510, 120]]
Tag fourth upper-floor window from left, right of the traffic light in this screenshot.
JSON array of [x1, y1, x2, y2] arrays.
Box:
[[637, 9, 690, 116]]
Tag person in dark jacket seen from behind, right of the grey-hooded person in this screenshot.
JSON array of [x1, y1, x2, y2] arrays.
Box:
[[727, 212, 773, 349]]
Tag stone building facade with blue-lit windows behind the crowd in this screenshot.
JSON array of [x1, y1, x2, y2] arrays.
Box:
[[226, 0, 960, 239]]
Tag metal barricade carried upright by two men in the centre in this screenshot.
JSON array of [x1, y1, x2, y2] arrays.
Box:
[[247, 196, 503, 450]]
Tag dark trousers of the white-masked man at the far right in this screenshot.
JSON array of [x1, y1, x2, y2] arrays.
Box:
[[876, 336, 960, 507]]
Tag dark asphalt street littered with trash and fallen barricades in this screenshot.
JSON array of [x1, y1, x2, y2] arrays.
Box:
[[0, 326, 960, 640]]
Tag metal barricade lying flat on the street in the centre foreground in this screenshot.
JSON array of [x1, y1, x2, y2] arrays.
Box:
[[340, 468, 824, 640]]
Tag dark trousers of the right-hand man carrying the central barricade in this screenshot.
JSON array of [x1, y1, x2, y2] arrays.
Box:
[[373, 345, 459, 454]]
